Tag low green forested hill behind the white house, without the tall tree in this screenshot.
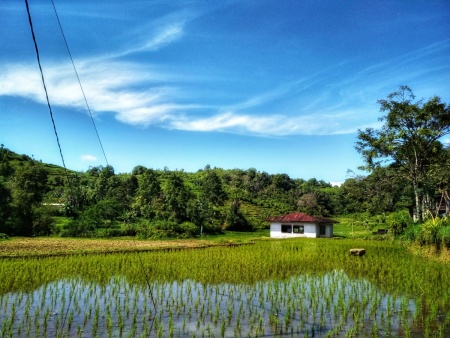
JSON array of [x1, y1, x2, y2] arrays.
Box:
[[0, 147, 411, 237]]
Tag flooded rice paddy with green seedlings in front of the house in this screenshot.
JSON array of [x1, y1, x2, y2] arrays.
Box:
[[0, 239, 450, 337]]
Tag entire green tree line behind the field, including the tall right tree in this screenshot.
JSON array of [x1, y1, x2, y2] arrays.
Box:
[[0, 86, 450, 246]]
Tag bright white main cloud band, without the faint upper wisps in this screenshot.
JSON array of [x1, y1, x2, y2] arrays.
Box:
[[0, 61, 378, 136]]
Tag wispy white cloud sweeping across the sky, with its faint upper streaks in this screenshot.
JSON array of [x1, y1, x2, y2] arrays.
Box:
[[0, 33, 450, 136]]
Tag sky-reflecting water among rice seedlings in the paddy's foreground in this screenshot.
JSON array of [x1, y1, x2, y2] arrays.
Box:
[[0, 271, 417, 337]]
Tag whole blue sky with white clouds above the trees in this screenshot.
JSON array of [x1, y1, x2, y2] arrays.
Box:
[[0, 0, 450, 182]]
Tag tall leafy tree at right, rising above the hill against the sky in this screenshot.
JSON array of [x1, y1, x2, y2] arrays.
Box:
[[355, 86, 450, 220]]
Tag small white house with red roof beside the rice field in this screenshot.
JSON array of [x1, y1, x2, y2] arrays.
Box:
[[266, 212, 339, 238]]
